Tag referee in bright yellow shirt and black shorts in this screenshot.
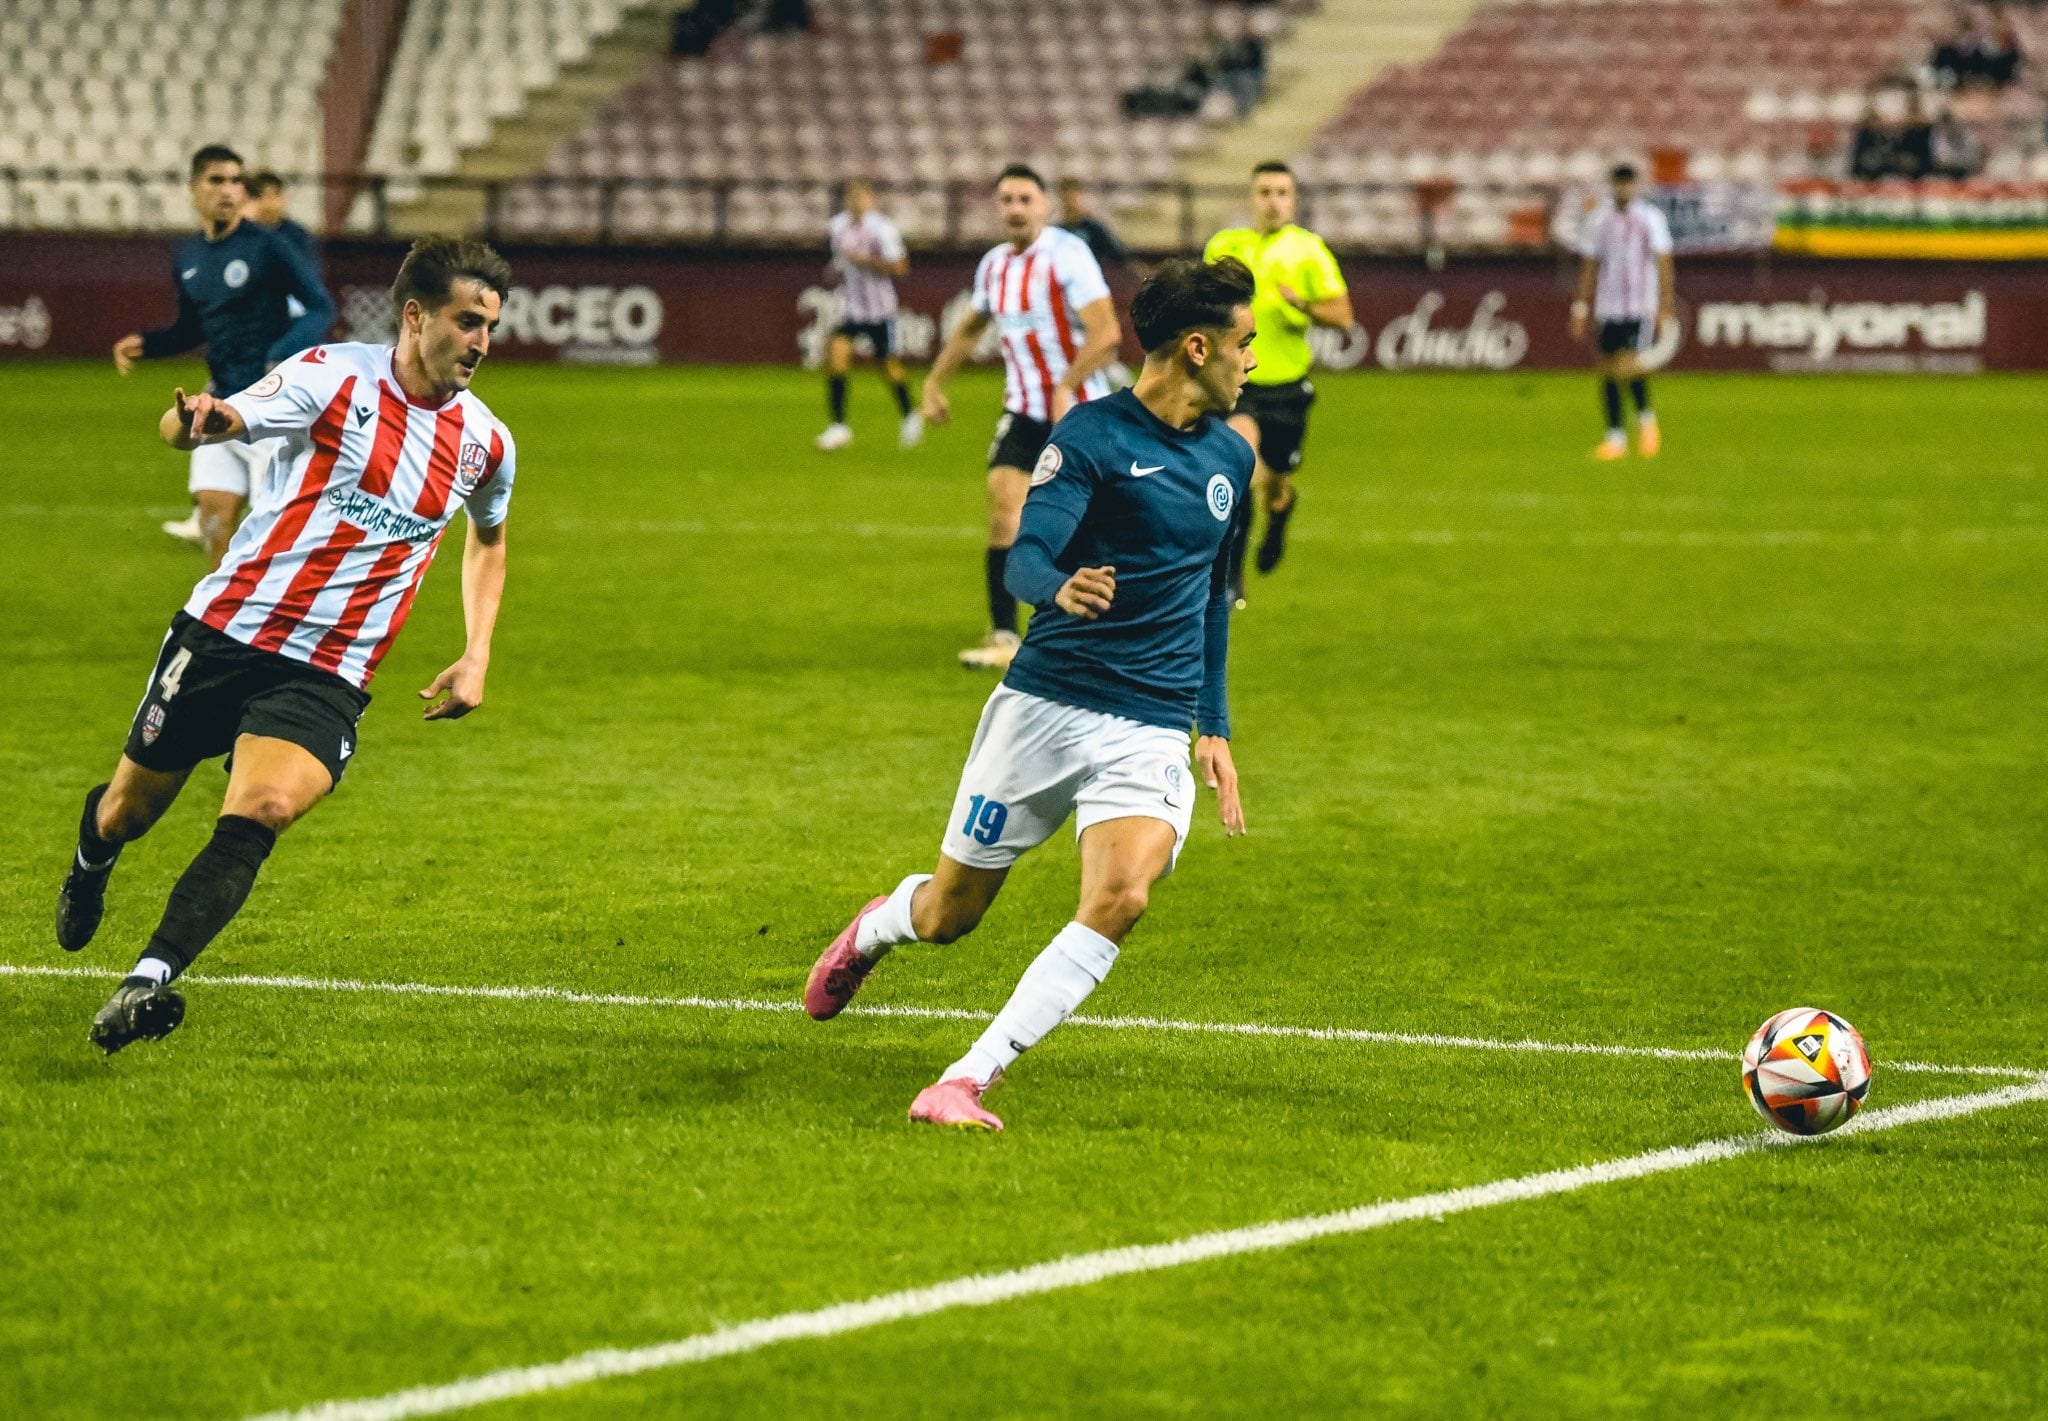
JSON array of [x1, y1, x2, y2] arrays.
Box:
[[1202, 162, 1352, 606]]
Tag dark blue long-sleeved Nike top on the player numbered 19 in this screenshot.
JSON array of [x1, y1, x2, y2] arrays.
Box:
[[1004, 389, 1251, 735]]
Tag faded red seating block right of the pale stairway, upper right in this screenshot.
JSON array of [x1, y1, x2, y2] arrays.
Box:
[[1296, 0, 2048, 246]]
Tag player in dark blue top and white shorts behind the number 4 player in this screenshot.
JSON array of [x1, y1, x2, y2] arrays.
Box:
[[115, 143, 334, 567]]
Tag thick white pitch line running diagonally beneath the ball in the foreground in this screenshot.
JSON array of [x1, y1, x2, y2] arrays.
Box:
[[256, 1077, 2048, 1421]]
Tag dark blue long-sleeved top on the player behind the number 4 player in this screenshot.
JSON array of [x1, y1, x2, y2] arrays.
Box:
[[141, 221, 334, 395]]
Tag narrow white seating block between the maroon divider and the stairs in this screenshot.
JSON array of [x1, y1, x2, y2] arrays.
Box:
[[365, 0, 629, 199]]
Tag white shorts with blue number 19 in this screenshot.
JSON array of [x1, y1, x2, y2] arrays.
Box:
[[938, 686, 1194, 872]]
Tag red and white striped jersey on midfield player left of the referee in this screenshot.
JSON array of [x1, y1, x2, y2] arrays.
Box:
[[975, 227, 1110, 420]]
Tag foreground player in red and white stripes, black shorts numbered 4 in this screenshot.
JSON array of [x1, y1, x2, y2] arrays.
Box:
[[57, 238, 514, 1054]]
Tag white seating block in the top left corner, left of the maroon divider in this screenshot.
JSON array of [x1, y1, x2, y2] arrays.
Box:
[[0, 0, 344, 229]]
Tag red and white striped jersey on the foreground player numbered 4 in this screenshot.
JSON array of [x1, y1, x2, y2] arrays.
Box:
[[184, 344, 514, 686]]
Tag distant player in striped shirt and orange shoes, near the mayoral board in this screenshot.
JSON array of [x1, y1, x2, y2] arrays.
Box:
[[1571, 164, 1677, 459]]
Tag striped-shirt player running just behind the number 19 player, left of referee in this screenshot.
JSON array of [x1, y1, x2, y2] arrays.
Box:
[[924, 164, 1120, 672]]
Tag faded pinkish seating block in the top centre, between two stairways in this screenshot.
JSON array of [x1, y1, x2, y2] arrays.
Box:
[[498, 0, 1269, 244]]
